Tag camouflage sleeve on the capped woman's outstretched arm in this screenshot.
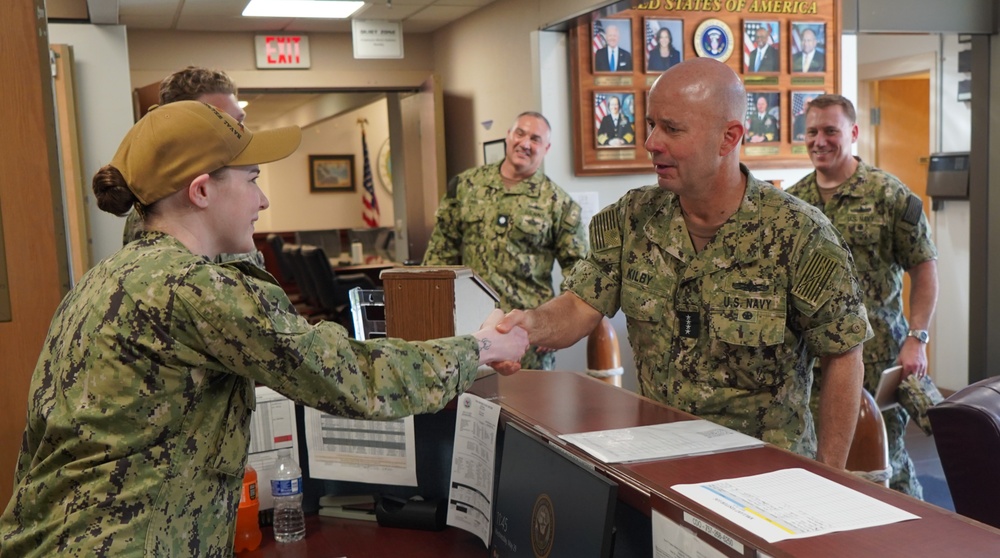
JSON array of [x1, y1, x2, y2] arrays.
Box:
[[178, 266, 479, 419]]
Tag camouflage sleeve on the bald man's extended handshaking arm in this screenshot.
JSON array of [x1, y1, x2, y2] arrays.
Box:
[[563, 196, 628, 317]]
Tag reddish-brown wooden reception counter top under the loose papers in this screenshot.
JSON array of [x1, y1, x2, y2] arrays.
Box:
[[471, 370, 1000, 558]]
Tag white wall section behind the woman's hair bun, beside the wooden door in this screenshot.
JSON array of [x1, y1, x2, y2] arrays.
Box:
[[49, 23, 132, 263]]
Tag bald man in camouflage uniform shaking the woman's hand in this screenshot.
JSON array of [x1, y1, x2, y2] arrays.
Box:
[[498, 58, 871, 468]]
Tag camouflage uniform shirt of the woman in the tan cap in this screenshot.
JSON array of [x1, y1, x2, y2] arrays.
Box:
[[0, 232, 479, 558]]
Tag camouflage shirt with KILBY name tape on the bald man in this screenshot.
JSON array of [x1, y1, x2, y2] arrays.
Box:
[[566, 167, 871, 457]]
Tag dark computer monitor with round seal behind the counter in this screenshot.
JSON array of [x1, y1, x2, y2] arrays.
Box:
[[490, 423, 618, 558]]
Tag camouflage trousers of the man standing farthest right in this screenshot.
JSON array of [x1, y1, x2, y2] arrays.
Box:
[[809, 362, 924, 500]]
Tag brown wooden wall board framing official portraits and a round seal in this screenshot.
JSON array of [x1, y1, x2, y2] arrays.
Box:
[[569, 0, 842, 176]]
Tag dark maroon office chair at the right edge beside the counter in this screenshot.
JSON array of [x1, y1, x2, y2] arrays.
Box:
[[927, 377, 1000, 527]]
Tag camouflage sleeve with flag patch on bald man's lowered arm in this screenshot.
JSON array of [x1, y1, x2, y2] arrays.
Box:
[[791, 223, 873, 356]]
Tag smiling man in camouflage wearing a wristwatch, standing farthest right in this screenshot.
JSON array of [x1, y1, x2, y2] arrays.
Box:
[[788, 95, 938, 498]]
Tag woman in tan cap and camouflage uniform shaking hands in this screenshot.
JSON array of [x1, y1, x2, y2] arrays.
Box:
[[0, 101, 527, 557]]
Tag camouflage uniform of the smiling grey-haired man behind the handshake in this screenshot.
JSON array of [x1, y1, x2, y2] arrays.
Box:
[[423, 163, 587, 370]]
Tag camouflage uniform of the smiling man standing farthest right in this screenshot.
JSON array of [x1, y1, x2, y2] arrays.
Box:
[[788, 159, 937, 498]]
